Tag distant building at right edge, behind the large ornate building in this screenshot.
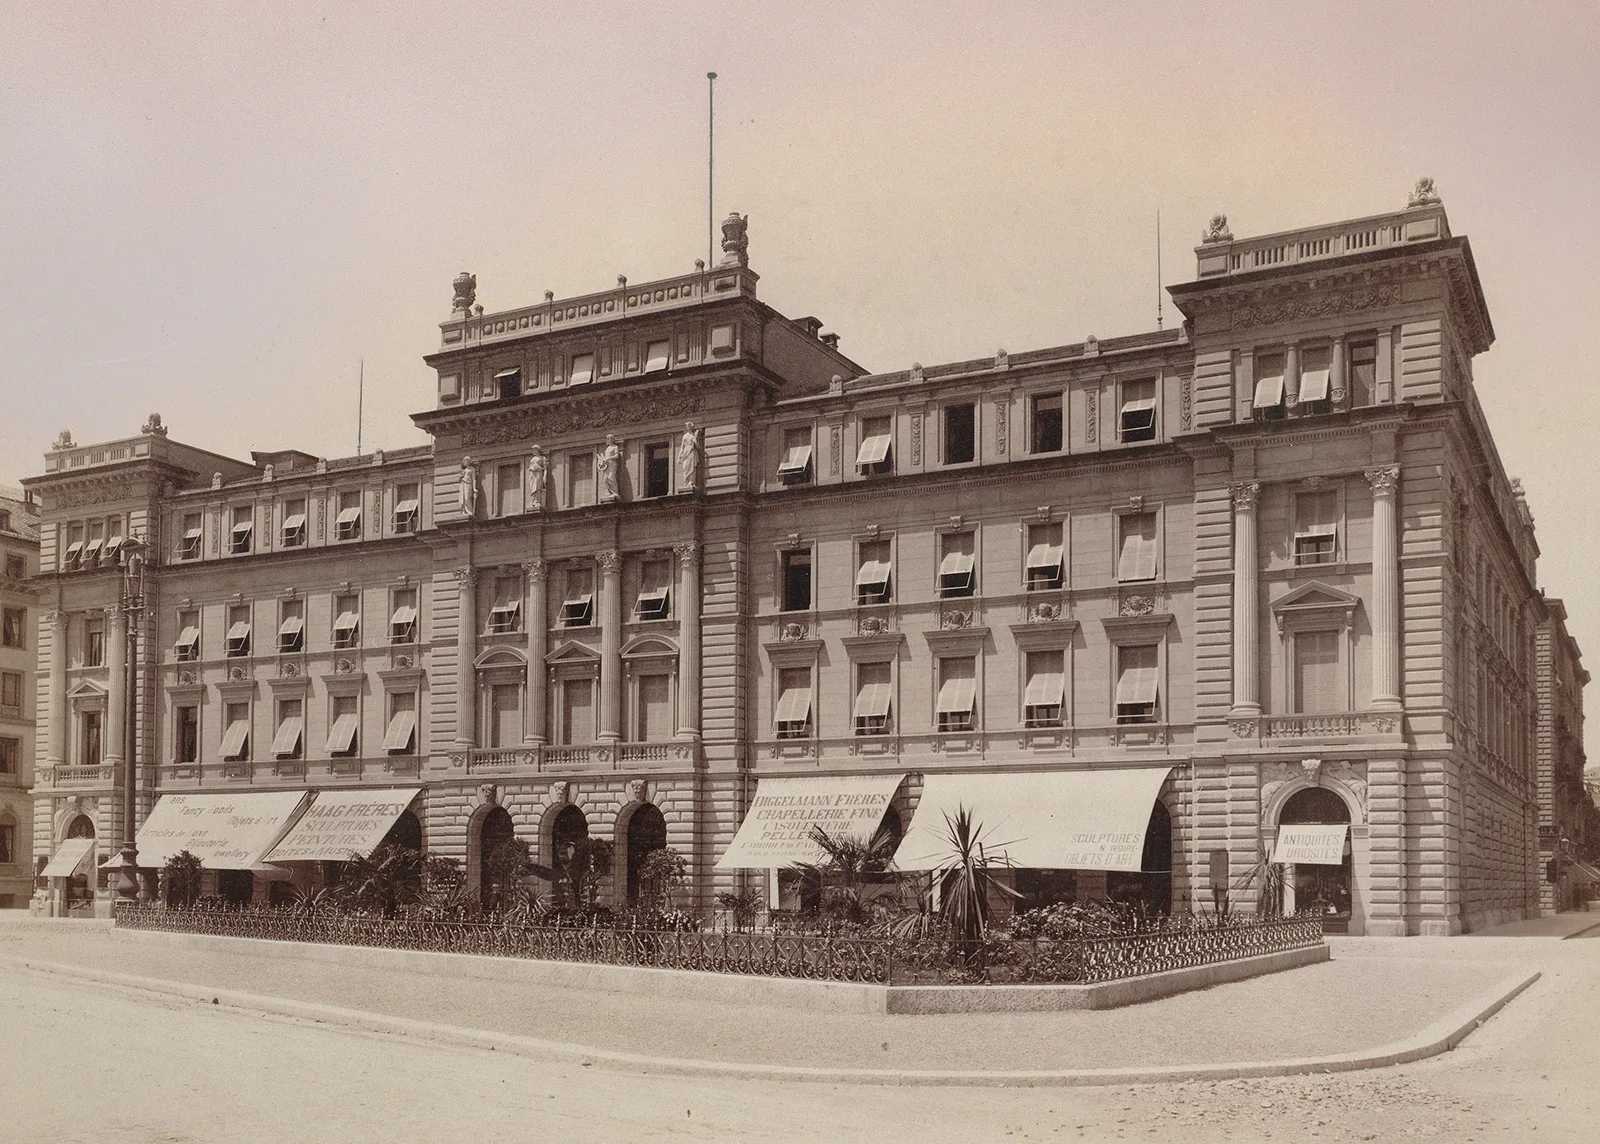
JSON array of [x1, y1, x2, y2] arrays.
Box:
[[1534, 600, 1594, 914]]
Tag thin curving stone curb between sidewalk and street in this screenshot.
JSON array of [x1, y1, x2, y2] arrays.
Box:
[[0, 957, 1541, 1088]]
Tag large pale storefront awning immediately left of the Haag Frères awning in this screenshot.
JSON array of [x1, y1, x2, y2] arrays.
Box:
[[134, 790, 307, 870]]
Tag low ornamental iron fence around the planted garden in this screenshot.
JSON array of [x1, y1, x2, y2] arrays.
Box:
[[115, 902, 1322, 986]]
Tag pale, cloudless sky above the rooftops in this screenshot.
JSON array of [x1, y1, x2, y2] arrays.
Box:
[[0, 0, 1600, 760]]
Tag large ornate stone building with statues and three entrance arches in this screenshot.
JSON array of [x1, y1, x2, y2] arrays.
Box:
[[18, 176, 1580, 934]]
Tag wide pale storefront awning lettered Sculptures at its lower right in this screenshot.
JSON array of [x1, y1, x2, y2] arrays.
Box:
[[894, 766, 1171, 872]]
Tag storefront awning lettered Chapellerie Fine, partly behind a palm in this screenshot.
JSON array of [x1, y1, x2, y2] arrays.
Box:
[[717, 773, 906, 870]]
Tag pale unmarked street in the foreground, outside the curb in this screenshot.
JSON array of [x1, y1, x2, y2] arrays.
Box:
[[0, 931, 1600, 1144]]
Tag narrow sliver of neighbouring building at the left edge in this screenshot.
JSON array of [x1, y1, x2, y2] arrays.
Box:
[[0, 488, 38, 909]]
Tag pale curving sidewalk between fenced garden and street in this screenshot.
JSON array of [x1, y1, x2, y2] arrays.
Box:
[[0, 922, 1548, 1083]]
